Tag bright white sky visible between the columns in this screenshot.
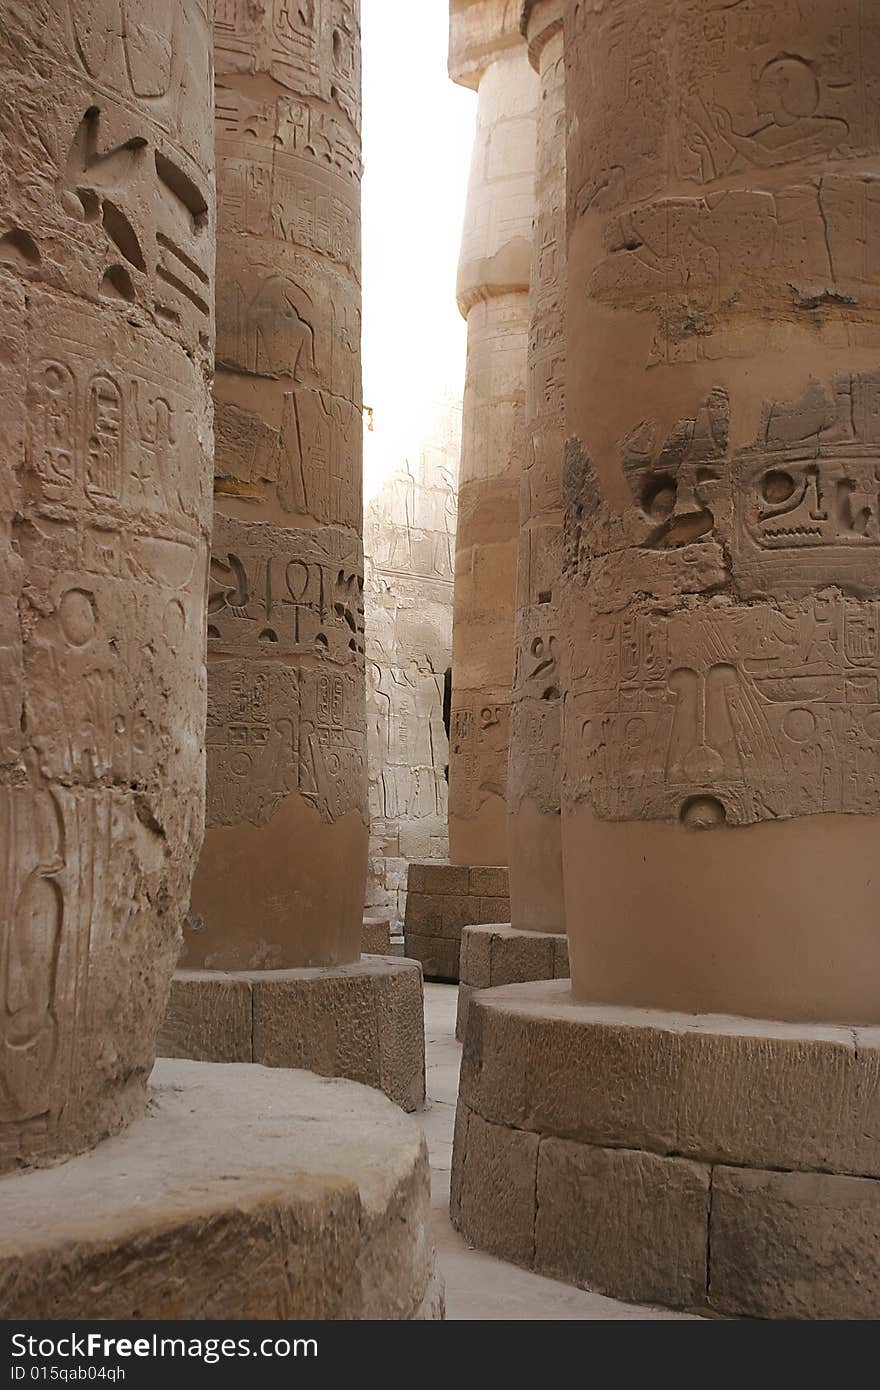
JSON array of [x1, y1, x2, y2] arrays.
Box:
[[361, 0, 477, 499]]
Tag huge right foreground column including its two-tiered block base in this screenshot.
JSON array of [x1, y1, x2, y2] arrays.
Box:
[[452, 0, 880, 1318]]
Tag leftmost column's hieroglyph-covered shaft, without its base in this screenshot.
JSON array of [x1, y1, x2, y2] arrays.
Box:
[[0, 0, 214, 1168]]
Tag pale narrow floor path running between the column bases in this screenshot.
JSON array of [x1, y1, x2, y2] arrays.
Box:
[[416, 984, 700, 1322]]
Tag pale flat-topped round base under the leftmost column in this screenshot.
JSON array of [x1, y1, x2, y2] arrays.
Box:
[[0, 1061, 443, 1321]]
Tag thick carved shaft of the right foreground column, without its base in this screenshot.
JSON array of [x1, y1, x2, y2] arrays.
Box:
[[563, 0, 880, 1023]]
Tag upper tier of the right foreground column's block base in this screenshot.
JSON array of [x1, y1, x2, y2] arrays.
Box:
[[460, 980, 880, 1176]]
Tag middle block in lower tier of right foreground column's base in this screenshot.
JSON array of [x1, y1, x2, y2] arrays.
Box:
[[534, 1138, 709, 1308]]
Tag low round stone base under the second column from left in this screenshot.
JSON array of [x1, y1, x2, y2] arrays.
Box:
[[157, 956, 425, 1111]]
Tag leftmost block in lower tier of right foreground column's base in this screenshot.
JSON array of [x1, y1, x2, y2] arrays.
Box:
[[453, 1113, 538, 1266]]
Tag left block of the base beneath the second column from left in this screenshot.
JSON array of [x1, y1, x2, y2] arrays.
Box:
[[157, 970, 253, 1062]]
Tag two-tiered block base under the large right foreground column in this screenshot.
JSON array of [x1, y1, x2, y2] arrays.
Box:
[[450, 980, 880, 1319]]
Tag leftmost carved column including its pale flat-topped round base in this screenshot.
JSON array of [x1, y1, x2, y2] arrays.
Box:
[[0, 0, 442, 1322]]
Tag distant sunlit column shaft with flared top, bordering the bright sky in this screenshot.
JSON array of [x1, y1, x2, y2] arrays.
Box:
[[449, 0, 538, 865]]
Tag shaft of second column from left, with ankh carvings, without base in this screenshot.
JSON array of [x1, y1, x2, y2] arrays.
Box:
[[184, 0, 368, 970]]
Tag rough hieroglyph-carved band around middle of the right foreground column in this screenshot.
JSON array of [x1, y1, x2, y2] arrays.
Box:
[[567, 373, 880, 824]]
